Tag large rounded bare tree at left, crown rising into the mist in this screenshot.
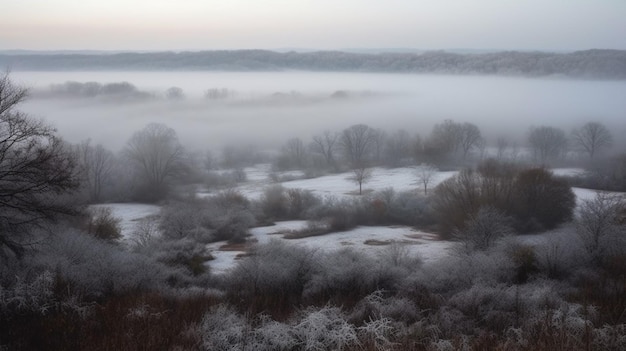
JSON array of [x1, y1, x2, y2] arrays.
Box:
[[124, 123, 184, 201]]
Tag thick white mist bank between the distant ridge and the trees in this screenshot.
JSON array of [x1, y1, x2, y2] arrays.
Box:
[[12, 71, 626, 150]]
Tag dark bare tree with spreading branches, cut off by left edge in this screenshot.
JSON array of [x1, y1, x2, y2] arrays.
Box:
[[0, 73, 79, 256]]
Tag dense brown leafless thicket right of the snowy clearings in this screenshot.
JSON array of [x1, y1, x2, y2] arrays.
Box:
[[433, 160, 576, 238]]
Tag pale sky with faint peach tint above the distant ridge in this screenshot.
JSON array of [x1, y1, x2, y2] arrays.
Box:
[[0, 0, 626, 50]]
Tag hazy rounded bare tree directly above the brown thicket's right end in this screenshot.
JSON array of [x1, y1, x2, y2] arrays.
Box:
[[528, 126, 567, 165]]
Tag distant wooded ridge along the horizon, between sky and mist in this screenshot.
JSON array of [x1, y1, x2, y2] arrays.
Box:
[[0, 50, 626, 80]]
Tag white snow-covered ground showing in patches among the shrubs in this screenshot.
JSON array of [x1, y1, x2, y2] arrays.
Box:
[[92, 164, 616, 273]]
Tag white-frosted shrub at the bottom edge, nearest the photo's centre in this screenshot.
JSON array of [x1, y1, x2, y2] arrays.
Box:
[[293, 306, 359, 351]]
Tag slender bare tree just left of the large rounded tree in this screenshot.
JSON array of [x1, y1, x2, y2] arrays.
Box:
[[78, 140, 114, 202]]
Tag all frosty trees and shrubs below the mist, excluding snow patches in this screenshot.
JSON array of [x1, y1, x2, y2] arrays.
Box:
[[0, 71, 626, 350]]
